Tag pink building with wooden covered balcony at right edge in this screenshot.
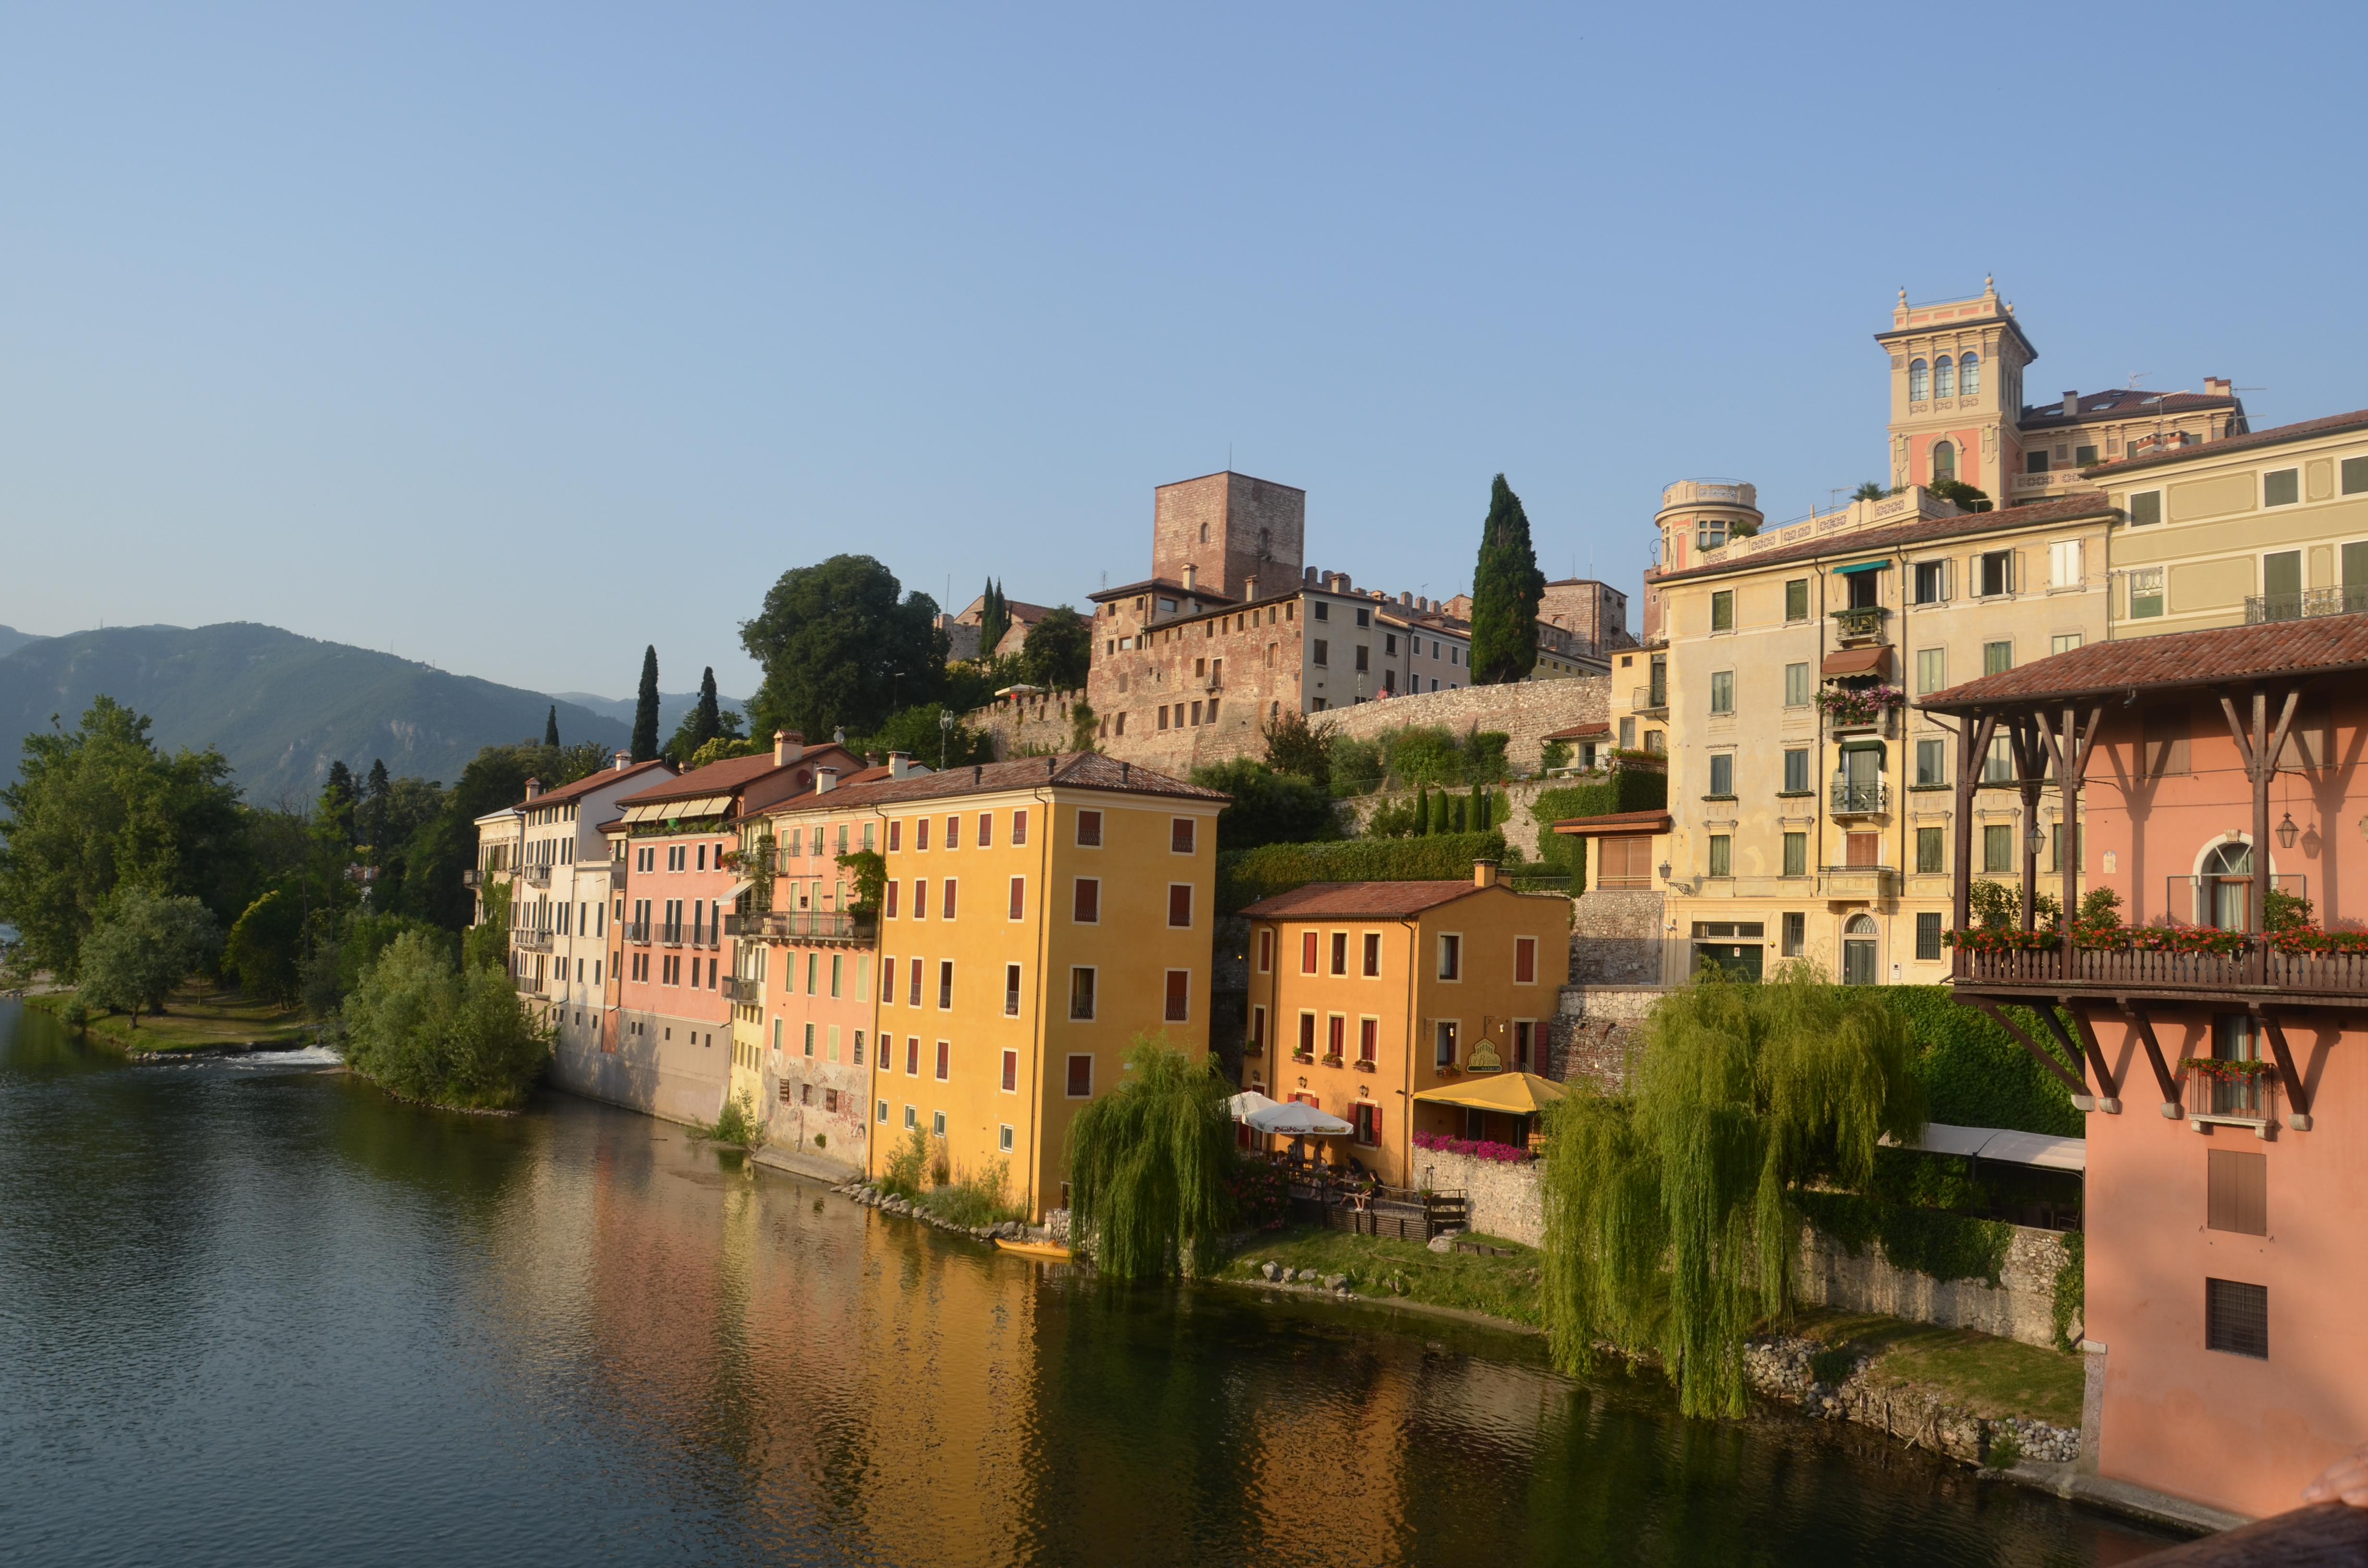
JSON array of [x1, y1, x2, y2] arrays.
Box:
[[1923, 616, 2368, 1514]]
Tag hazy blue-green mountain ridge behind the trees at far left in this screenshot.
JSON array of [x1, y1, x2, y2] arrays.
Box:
[[0, 621, 632, 803]]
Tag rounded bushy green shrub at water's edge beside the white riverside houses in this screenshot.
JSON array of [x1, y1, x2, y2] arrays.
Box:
[[345, 931, 552, 1108]]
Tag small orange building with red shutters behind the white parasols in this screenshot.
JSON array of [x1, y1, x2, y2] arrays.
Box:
[[1243, 860, 1570, 1187]]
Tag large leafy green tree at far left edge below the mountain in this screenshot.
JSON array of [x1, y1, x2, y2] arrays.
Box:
[[0, 697, 251, 980]]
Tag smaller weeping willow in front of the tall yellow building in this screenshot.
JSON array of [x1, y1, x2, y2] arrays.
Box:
[[1068, 1035, 1236, 1284]]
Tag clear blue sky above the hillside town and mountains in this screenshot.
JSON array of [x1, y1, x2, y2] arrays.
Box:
[[0, 5, 2368, 694]]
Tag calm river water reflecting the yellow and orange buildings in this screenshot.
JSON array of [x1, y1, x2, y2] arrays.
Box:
[[0, 1002, 2164, 1568]]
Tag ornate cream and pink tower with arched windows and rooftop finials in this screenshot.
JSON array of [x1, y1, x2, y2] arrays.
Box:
[[1875, 277, 2039, 507]]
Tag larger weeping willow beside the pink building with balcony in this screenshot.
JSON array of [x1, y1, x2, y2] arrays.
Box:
[[1542, 964, 1925, 1416]]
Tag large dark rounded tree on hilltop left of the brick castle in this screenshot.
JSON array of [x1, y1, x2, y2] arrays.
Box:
[[741, 554, 947, 736]]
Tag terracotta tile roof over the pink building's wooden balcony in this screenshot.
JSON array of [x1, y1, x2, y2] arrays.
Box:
[[1916, 616, 2368, 710]]
